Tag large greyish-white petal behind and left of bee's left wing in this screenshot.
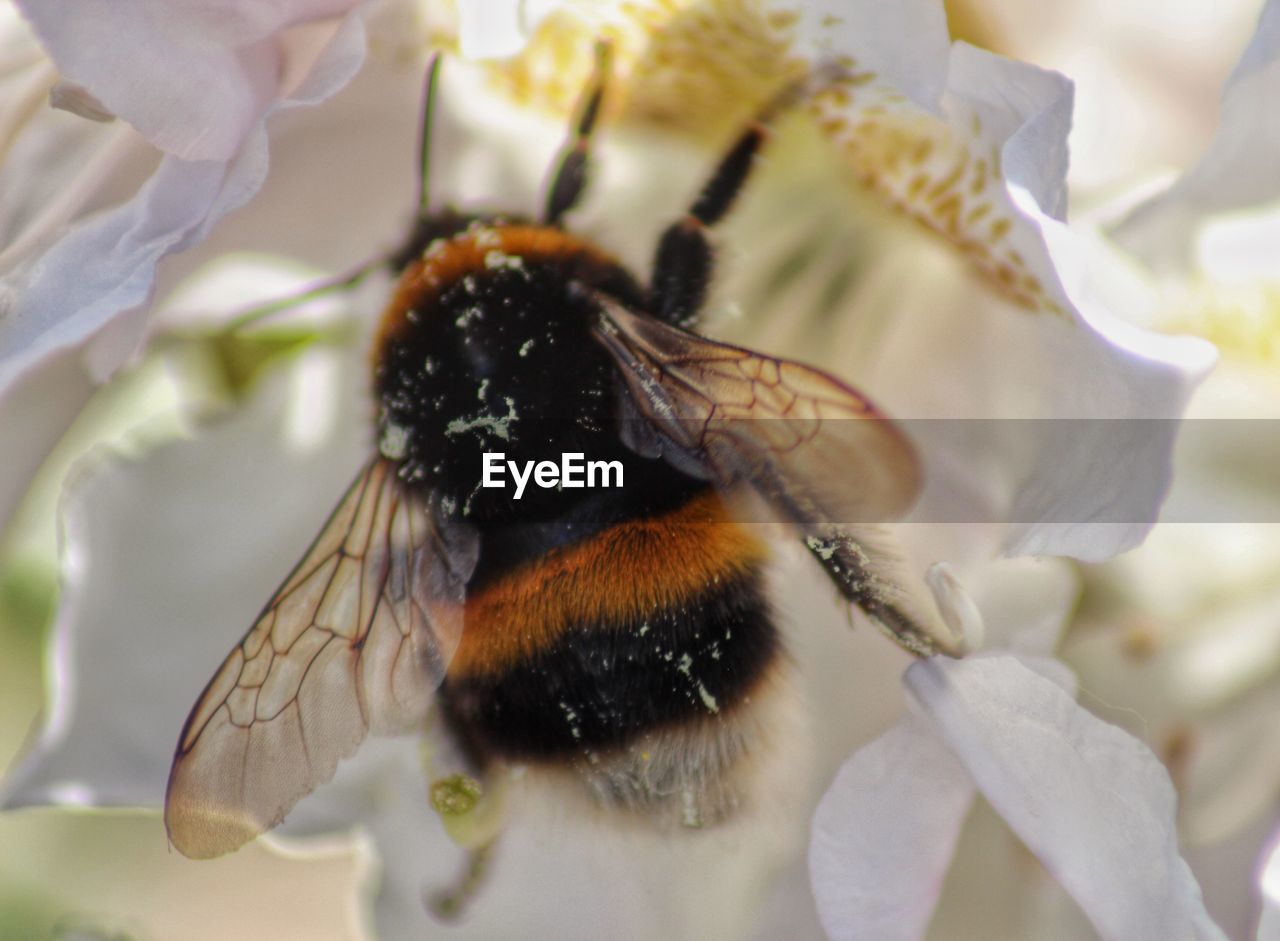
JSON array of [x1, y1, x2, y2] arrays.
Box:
[[4, 356, 362, 807]]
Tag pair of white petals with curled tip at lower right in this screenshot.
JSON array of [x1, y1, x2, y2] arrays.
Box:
[[809, 565, 1225, 941]]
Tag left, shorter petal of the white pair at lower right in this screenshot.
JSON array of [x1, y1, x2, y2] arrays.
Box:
[[809, 714, 974, 941]]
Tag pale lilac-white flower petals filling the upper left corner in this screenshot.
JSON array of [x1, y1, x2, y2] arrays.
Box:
[[0, 0, 365, 524]]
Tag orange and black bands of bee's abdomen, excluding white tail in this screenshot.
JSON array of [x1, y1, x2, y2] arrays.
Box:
[[443, 490, 781, 760]]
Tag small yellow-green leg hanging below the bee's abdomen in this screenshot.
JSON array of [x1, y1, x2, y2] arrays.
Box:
[[426, 768, 506, 919]]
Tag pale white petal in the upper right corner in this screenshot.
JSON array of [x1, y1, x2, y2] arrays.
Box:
[[1114, 0, 1280, 270]]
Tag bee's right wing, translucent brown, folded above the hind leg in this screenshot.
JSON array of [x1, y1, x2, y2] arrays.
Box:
[[596, 296, 920, 530]]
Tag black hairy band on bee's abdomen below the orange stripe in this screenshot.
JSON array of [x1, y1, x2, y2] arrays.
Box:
[[440, 573, 781, 763]]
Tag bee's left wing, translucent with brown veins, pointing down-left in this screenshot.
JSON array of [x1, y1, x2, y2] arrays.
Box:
[[165, 460, 476, 858]]
